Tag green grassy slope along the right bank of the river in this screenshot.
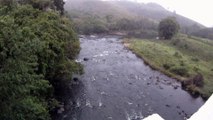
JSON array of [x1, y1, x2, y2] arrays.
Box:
[[126, 35, 213, 96]]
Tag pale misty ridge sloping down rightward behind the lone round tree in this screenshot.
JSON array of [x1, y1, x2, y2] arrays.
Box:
[[114, 1, 203, 27]]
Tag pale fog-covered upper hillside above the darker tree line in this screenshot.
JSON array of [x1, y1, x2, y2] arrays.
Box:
[[65, 0, 205, 34]]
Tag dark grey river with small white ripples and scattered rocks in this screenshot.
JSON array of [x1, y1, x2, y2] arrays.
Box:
[[56, 36, 204, 120]]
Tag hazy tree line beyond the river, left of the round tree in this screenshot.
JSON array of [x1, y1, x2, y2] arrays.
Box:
[[71, 13, 157, 37]]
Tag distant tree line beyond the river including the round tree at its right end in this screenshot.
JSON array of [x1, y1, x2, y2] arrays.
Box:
[[71, 13, 180, 39]]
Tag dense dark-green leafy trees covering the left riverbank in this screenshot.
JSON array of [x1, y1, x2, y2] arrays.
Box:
[[0, 0, 81, 120]]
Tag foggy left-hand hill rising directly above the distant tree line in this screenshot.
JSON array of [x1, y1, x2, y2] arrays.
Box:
[[65, 0, 134, 18]]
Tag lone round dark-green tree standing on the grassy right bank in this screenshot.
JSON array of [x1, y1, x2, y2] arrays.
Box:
[[158, 17, 180, 39]]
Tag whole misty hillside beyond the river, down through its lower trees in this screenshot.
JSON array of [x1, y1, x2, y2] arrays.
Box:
[[65, 0, 205, 33]]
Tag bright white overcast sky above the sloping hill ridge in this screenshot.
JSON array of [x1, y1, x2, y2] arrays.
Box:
[[132, 0, 213, 27]]
